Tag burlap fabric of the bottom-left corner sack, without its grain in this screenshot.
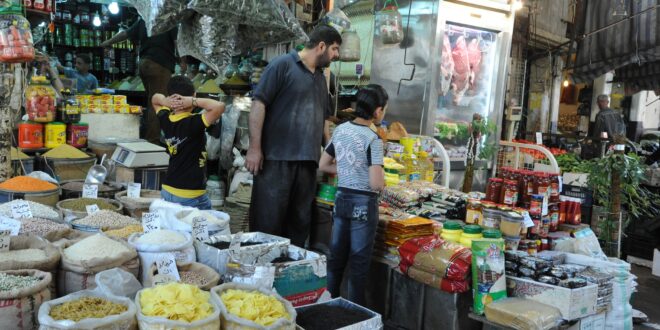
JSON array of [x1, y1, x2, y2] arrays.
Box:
[[0, 269, 53, 330]]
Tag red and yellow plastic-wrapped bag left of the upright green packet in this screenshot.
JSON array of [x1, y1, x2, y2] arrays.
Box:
[[399, 236, 472, 281]]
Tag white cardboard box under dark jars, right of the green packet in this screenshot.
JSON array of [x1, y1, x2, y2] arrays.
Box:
[[506, 276, 598, 321]]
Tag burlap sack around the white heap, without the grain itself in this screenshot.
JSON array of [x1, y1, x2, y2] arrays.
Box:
[[57, 239, 140, 296]]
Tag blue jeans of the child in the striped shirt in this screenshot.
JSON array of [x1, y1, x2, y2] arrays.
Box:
[[328, 191, 378, 306]]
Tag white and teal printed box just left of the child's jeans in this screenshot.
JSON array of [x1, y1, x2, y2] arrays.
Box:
[[273, 245, 330, 307]]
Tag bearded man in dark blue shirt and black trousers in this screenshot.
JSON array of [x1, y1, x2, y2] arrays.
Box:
[[247, 26, 342, 246]]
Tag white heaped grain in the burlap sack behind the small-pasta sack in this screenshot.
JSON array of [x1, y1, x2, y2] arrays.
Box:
[[64, 234, 131, 262]]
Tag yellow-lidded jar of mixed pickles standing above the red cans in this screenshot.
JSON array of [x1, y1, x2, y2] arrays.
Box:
[[25, 76, 56, 123]]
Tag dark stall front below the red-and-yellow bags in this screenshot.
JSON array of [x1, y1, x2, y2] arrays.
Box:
[[366, 257, 481, 330]]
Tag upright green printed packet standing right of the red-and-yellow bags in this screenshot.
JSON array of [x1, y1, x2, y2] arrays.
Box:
[[472, 238, 506, 314]]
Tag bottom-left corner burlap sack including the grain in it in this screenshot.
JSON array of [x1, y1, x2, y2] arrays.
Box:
[[0, 269, 52, 330]]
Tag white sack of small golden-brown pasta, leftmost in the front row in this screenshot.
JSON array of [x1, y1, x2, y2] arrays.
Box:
[[39, 290, 137, 330]]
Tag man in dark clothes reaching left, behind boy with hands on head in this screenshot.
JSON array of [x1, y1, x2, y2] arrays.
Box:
[[101, 18, 178, 143]]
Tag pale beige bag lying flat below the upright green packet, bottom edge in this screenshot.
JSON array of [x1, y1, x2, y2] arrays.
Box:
[[485, 298, 561, 330]]
